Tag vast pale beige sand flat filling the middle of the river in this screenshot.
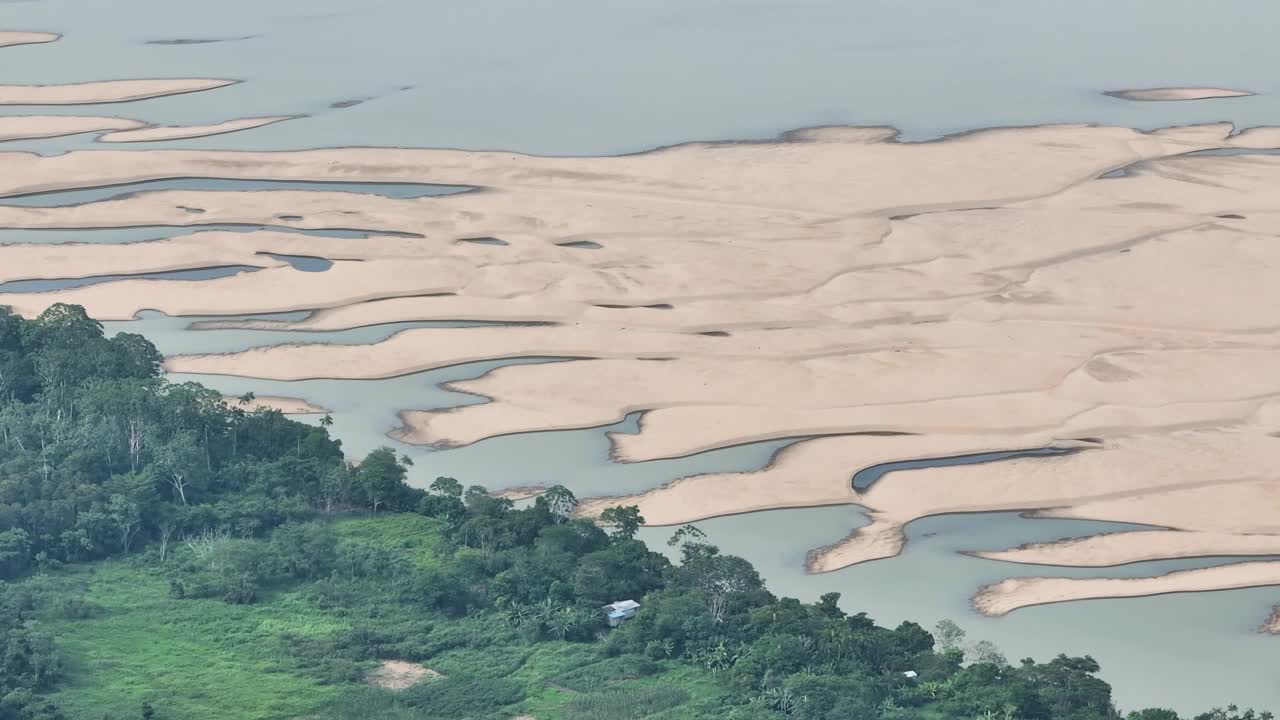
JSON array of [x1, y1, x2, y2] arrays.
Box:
[[0, 119, 1280, 609]]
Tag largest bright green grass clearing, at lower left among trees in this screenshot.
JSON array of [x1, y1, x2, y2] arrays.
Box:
[[45, 562, 346, 720]]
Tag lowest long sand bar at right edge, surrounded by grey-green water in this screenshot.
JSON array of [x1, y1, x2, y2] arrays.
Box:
[[973, 561, 1280, 616]]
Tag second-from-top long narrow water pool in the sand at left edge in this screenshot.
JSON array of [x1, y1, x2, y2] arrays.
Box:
[[0, 223, 424, 245]]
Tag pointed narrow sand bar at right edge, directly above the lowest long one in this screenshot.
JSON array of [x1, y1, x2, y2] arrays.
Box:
[[965, 527, 1280, 568]]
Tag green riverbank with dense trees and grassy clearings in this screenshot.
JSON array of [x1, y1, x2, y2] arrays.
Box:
[[0, 305, 1271, 720]]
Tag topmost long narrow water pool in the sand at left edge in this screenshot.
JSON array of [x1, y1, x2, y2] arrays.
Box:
[[0, 178, 471, 208]]
